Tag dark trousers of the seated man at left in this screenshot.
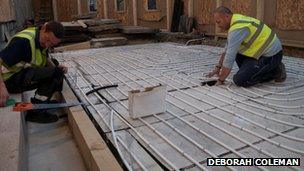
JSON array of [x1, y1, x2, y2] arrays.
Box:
[[5, 67, 64, 99]]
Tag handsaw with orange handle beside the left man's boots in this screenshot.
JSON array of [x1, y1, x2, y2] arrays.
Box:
[[13, 102, 85, 112]]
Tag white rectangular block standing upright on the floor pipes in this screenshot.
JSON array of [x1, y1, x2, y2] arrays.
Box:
[[129, 85, 167, 119]]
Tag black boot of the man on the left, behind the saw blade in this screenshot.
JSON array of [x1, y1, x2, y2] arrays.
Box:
[[25, 98, 58, 123]]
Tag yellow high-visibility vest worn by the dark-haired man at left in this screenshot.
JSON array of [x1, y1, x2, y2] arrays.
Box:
[[1, 27, 46, 81]]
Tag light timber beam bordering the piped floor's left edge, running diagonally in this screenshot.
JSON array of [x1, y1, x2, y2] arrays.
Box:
[[62, 82, 122, 171]]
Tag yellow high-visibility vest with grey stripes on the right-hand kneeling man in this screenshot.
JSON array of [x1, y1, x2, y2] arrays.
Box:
[[228, 14, 276, 59]]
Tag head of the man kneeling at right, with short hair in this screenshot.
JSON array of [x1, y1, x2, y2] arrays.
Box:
[[213, 6, 233, 31]]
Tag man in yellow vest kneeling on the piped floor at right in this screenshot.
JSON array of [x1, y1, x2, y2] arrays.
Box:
[[207, 6, 286, 87]]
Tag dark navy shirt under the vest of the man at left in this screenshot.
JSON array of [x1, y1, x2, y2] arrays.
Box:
[[0, 28, 43, 67]]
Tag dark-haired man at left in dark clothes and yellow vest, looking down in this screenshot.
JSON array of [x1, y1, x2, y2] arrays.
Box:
[[0, 21, 67, 123]]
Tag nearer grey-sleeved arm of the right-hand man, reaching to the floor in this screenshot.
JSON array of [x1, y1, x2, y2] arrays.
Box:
[[216, 28, 250, 85]]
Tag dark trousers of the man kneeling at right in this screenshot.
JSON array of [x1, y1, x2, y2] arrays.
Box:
[[233, 51, 283, 87]]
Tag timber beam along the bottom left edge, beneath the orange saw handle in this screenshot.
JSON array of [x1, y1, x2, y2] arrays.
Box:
[[0, 94, 26, 171]]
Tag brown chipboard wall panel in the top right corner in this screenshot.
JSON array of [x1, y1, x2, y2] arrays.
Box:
[[276, 0, 304, 30]]
